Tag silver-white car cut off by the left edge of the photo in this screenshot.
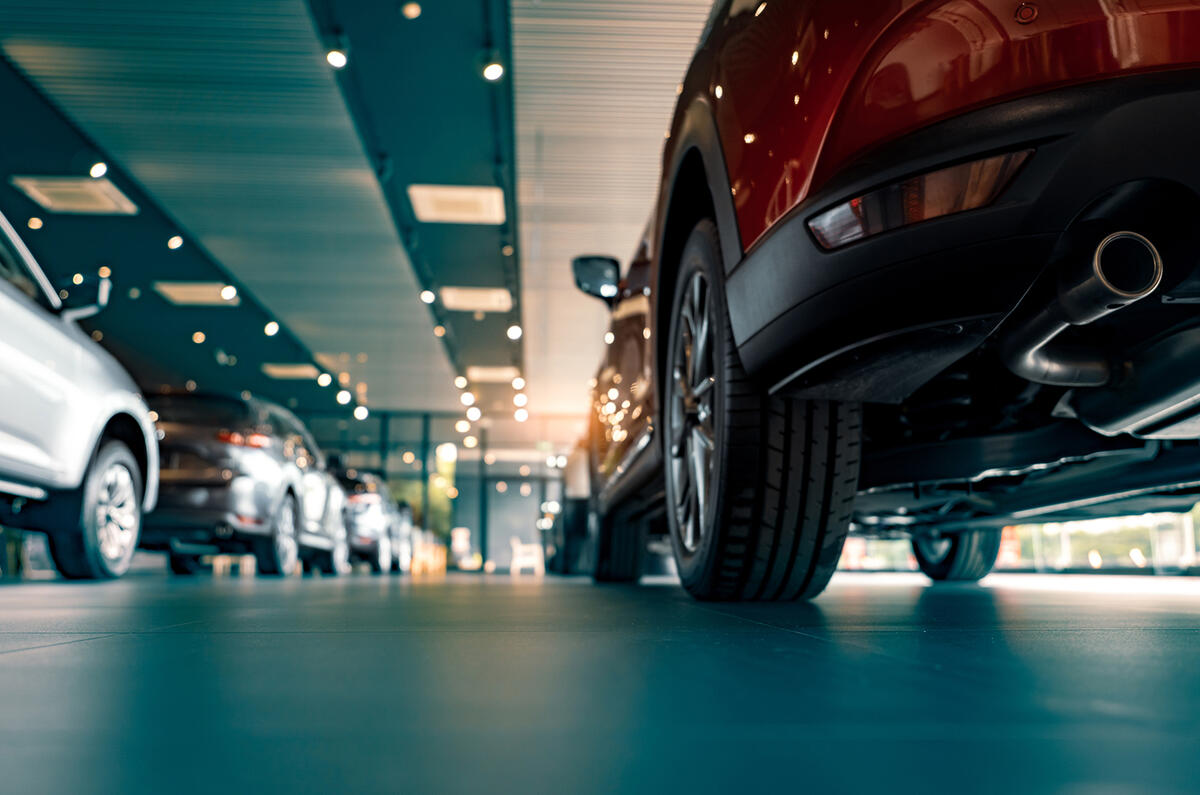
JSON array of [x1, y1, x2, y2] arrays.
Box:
[[0, 206, 158, 579]]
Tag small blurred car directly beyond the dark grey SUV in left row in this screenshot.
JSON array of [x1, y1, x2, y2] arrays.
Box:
[[337, 470, 413, 574]]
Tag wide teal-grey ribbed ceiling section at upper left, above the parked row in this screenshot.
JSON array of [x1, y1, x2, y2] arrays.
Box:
[[0, 0, 456, 408]]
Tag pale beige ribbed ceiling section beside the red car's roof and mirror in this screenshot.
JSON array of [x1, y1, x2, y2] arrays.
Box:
[[512, 0, 712, 422]]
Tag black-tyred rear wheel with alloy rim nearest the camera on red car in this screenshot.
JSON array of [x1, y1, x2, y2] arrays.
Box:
[[662, 220, 862, 600]]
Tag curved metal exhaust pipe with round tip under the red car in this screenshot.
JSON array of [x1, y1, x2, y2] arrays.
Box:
[[1000, 232, 1163, 387]]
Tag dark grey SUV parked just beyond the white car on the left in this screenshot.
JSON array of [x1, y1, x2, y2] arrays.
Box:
[[142, 393, 349, 575]]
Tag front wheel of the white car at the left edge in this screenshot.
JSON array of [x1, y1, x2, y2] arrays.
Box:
[[47, 440, 143, 580]]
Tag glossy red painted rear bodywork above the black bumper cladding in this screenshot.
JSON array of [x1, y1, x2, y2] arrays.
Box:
[[689, 0, 1200, 250]]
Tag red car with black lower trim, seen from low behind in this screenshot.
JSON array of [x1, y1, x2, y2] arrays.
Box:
[[575, 0, 1200, 599]]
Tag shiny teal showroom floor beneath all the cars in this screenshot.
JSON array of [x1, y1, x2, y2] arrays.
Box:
[[0, 573, 1200, 795]]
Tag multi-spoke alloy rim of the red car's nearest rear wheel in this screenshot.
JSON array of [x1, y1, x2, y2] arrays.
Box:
[[667, 273, 716, 552]]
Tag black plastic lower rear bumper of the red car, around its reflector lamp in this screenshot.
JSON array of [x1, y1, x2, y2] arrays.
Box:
[[727, 71, 1200, 400]]
